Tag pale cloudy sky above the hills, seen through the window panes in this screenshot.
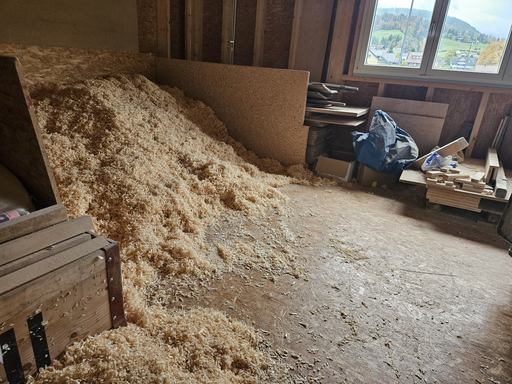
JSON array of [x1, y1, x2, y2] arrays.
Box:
[[378, 0, 512, 37]]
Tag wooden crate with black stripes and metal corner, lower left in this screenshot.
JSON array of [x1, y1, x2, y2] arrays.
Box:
[[0, 222, 126, 384]]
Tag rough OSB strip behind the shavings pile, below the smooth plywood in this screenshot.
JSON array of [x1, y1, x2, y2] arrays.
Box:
[[0, 44, 155, 85]]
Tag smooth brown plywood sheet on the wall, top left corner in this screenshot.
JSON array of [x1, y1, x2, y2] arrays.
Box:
[[0, 0, 139, 52]]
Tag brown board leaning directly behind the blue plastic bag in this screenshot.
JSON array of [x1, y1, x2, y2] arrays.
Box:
[[388, 112, 444, 156]]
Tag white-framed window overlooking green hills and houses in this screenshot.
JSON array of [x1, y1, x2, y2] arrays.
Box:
[[354, 0, 512, 86]]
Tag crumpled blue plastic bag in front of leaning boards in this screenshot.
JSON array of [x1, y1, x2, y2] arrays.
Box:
[[352, 110, 419, 173]]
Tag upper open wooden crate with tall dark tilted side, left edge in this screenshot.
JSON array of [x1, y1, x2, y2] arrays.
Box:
[[0, 56, 68, 243]]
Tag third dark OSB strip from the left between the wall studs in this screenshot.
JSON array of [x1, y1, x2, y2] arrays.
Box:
[[203, 0, 222, 63]]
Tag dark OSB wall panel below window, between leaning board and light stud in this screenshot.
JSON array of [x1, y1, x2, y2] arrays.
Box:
[[432, 88, 482, 145]]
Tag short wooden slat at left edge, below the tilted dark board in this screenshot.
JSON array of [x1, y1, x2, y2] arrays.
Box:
[[0, 204, 68, 244]]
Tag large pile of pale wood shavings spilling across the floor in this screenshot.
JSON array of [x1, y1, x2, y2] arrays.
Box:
[[31, 75, 328, 383]]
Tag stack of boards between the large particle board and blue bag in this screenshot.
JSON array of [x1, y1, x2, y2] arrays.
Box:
[[305, 83, 369, 127]]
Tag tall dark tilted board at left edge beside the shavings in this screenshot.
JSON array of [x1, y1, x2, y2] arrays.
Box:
[[0, 56, 60, 208]]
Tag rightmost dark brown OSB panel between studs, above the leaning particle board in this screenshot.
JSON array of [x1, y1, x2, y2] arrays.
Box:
[[263, 0, 295, 68]]
